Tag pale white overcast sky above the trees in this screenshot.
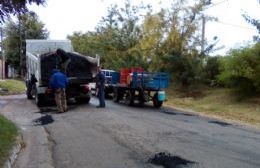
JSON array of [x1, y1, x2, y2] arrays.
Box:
[[28, 0, 260, 54]]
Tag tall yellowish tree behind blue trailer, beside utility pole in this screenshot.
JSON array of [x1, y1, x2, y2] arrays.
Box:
[[147, 0, 210, 86]]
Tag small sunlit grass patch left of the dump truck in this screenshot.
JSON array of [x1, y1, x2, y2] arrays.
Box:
[[0, 79, 26, 95]]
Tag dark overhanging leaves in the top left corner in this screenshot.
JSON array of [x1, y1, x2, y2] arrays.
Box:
[[0, 0, 46, 23]]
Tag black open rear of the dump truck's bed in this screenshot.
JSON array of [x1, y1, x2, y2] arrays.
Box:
[[40, 49, 97, 85]]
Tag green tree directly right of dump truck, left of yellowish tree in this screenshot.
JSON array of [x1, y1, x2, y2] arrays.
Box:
[[69, 0, 150, 70]]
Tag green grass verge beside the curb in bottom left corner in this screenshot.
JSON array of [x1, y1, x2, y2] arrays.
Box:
[[0, 115, 17, 167]]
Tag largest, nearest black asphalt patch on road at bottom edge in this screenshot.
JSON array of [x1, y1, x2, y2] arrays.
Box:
[[148, 152, 198, 168]]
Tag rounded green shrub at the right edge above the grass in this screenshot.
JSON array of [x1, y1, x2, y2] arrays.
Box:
[[218, 43, 260, 96]]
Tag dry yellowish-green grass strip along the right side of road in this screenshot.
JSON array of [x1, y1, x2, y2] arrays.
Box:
[[166, 88, 260, 127]]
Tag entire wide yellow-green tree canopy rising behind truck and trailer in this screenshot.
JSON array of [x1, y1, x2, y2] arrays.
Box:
[[68, 0, 216, 84]]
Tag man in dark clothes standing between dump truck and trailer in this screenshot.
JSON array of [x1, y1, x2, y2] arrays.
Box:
[[96, 67, 106, 108]]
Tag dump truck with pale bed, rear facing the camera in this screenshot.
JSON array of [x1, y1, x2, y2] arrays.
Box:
[[26, 40, 99, 106]]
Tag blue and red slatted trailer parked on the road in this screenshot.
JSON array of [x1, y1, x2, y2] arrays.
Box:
[[112, 68, 169, 108]]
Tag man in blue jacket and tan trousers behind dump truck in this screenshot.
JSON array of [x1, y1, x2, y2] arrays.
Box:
[[50, 69, 68, 113]]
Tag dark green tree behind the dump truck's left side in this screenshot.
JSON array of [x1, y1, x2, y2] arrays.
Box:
[[4, 12, 49, 75]]
